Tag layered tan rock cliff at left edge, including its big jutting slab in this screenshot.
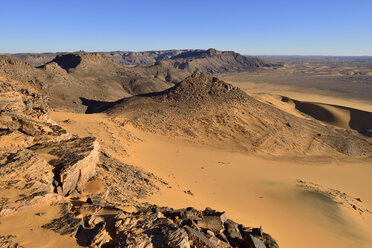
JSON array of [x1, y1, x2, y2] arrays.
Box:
[[0, 78, 99, 215]]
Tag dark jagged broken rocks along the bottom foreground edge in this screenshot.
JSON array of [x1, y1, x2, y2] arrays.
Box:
[[66, 206, 278, 248]]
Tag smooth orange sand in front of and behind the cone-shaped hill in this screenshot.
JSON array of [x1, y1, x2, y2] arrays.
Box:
[[48, 74, 372, 247]]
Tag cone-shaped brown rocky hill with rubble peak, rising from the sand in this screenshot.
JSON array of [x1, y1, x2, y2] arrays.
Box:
[[101, 72, 372, 157]]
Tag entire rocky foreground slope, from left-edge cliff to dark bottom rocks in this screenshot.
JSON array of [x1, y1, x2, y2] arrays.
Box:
[[0, 71, 278, 248]]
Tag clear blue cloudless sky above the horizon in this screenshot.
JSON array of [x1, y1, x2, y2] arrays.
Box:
[[0, 0, 372, 55]]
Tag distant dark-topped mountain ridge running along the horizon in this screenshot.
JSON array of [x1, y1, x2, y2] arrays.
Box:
[[8, 48, 270, 73]]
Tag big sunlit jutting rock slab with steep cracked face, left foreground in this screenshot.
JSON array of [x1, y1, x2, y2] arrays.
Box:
[[0, 137, 99, 215]]
